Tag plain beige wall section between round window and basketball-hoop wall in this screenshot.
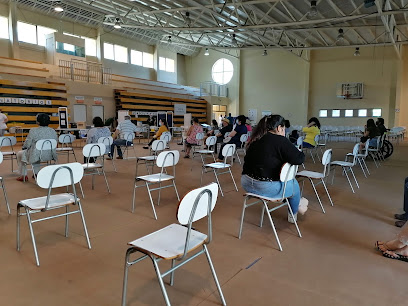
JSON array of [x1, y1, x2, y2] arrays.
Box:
[[240, 50, 309, 124]]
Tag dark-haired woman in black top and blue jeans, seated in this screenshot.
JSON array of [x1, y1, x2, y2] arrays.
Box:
[[241, 115, 305, 222]]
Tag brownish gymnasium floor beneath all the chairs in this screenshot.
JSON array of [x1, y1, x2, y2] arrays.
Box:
[[0, 142, 408, 306]]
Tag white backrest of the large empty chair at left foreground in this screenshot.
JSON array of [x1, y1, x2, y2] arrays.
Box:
[[37, 163, 84, 189]]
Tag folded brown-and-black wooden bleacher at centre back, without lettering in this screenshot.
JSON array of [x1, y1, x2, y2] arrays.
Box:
[[115, 89, 207, 126]]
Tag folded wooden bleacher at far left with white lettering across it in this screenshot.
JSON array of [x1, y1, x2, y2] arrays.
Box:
[[0, 80, 69, 141]]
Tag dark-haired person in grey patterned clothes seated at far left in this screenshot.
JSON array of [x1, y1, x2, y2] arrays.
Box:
[[17, 114, 58, 182]]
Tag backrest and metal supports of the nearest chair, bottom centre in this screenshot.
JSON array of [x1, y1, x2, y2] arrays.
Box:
[[177, 183, 218, 259]]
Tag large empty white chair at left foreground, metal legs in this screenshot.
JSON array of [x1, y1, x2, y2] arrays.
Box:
[[17, 163, 91, 266]]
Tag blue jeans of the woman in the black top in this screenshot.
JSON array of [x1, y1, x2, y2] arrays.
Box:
[[241, 175, 300, 214]]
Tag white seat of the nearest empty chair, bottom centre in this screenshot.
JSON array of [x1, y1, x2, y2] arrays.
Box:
[[128, 224, 207, 259]]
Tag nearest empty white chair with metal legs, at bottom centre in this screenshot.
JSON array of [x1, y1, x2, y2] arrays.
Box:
[[122, 183, 227, 306]]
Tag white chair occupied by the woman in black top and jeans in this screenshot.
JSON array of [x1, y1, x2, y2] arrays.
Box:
[[238, 163, 302, 251]]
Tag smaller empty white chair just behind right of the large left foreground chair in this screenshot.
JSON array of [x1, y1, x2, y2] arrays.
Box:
[[79, 143, 110, 198]]
